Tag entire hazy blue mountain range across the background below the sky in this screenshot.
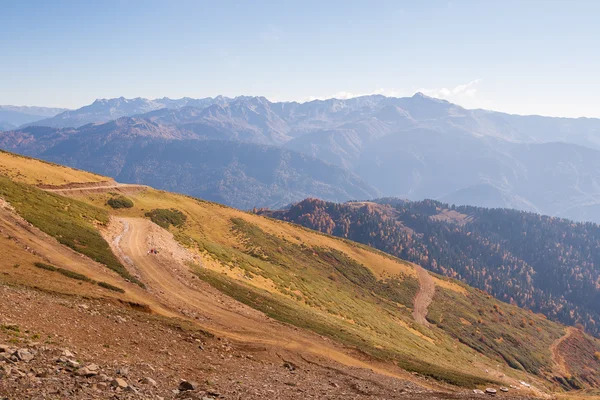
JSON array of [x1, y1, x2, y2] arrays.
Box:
[[0, 93, 600, 222]]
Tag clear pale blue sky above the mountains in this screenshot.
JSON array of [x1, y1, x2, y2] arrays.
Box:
[[0, 0, 600, 117]]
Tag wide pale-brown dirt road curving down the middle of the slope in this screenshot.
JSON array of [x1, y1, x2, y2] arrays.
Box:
[[108, 218, 422, 386]]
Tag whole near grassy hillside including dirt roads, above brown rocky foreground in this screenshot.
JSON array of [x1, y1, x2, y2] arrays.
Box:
[[0, 155, 600, 398]]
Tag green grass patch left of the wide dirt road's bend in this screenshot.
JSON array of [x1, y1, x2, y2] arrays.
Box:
[[0, 176, 140, 284]]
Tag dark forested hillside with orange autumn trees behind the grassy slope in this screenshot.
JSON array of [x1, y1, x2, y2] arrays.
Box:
[[260, 199, 600, 336]]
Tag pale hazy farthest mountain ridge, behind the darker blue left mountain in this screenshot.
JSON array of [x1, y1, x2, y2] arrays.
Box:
[[3, 94, 600, 222]]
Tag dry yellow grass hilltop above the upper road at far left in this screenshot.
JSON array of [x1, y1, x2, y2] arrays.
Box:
[[0, 151, 105, 186]]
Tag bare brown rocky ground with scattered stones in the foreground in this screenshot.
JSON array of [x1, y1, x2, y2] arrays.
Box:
[[0, 285, 536, 400]]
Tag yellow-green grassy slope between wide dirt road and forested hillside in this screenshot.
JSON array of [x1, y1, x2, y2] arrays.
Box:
[[71, 190, 580, 385]]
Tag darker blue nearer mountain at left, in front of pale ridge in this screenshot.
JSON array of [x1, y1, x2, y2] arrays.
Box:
[[0, 118, 378, 209]]
